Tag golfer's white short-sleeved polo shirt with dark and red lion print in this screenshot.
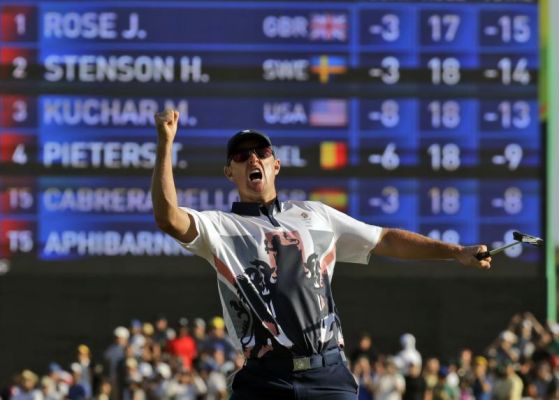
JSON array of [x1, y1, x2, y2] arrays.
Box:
[[177, 201, 382, 358]]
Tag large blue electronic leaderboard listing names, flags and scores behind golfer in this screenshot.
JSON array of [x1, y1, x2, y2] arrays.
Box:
[[0, 0, 546, 276]]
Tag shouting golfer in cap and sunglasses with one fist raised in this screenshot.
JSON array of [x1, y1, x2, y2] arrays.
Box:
[[152, 110, 491, 400]]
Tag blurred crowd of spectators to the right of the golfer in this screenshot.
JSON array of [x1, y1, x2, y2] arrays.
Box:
[[350, 313, 559, 400]]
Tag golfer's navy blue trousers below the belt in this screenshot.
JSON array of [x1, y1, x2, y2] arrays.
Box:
[[230, 362, 357, 400]]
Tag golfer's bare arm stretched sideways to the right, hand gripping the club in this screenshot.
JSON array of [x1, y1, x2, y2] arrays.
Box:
[[373, 228, 491, 269]]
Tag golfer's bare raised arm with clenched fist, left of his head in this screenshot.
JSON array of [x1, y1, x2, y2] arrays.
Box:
[[151, 110, 198, 243]]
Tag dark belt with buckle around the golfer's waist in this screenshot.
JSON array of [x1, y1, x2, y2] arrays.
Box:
[[246, 349, 347, 372]]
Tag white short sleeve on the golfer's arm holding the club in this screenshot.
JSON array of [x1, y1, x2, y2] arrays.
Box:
[[322, 204, 382, 264]]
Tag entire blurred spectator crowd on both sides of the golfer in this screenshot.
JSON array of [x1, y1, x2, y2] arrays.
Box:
[[0, 313, 559, 400]]
